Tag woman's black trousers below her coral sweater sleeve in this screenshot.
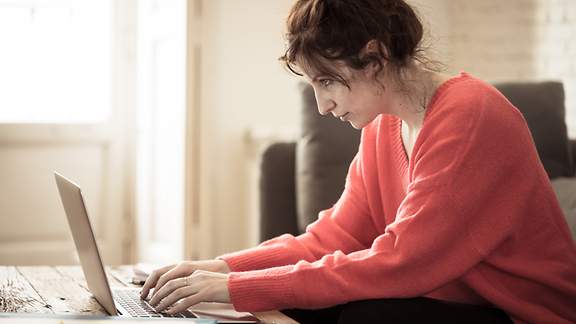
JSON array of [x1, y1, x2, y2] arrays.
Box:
[[282, 297, 512, 324]]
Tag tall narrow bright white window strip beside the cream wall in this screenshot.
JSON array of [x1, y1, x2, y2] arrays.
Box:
[[136, 0, 187, 263]]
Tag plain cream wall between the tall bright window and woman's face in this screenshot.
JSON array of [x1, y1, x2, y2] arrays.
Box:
[[200, 0, 299, 257]]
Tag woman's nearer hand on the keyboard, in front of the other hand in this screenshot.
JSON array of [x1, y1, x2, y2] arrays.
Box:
[[149, 270, 230, 314]]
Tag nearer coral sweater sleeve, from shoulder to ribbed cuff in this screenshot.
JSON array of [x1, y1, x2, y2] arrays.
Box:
[[229, 93, 537, 311]]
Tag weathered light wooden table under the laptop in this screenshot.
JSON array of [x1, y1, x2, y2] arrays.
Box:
[[0, 266, 297, 324]]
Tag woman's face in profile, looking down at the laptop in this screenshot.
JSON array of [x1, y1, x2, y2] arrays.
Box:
[[305, 65, 389, 129]]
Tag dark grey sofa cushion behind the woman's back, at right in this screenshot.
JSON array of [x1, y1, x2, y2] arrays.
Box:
[[495, 82, 574, 179]]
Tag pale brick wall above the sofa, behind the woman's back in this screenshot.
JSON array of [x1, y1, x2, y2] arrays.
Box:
[[424, 0, 576, 138]]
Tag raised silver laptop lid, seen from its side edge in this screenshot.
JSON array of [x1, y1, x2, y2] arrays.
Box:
[[54, 172, 118, 315]]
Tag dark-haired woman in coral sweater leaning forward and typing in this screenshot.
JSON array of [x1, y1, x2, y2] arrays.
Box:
[[142, 0, 576, 323]]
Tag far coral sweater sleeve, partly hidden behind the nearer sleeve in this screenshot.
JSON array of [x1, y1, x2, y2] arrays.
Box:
[[218, 141, 378, 271]]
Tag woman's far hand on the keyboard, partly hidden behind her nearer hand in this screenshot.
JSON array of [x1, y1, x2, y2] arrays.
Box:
[[140, 259, 230, 299]]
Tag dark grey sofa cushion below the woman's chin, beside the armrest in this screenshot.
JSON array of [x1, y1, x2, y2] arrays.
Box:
[[296, 83, 360, 232]]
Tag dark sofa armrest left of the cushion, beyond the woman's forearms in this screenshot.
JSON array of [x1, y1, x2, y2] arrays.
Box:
[[260, 142, 298, 241]]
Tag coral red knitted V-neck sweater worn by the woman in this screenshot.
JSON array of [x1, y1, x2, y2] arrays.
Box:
[[219, 73, 576, 323]]
